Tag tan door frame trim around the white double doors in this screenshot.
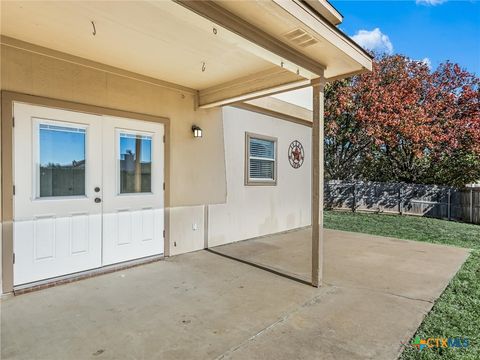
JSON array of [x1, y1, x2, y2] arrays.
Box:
[[1, 91, 170, 293]]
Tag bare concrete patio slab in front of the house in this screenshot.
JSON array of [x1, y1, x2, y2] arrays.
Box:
[[1, 229, 468, 359]]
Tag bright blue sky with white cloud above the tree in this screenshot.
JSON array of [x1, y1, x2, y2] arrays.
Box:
[[331, 0, 480, 76]]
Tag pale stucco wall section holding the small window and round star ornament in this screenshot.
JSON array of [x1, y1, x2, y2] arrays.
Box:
[[208, 107, 311, 246]]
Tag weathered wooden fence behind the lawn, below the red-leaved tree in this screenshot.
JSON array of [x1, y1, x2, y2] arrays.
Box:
[[325, 180, 480, 224]]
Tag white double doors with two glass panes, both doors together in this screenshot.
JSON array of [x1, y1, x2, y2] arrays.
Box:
[[13, 103, 164, 285]]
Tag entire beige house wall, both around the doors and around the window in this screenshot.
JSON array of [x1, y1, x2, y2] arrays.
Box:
[[0, 45, 311, 290]]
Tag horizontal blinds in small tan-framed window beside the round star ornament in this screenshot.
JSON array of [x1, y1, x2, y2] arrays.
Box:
[[249, 138, 275, 180]]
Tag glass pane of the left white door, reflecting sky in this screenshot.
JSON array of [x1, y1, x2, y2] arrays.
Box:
[[39, 124, 85, 197]]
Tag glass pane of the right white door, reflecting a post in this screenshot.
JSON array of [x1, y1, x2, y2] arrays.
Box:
[[120, 133, 152, 194]]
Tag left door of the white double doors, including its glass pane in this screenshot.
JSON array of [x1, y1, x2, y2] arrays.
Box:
[[13, 103, 102, 285]]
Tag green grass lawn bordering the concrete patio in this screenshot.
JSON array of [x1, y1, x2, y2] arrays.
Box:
[[324, 211, 480, 360]]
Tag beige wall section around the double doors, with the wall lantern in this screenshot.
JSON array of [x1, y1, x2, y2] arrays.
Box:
[[1, 45, 226, 270]]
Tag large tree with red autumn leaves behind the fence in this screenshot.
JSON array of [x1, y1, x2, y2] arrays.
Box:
[[325, 55, 480, 186]]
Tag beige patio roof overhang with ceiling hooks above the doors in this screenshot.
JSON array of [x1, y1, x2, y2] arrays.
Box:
[[1, 0, 371, 108]]
